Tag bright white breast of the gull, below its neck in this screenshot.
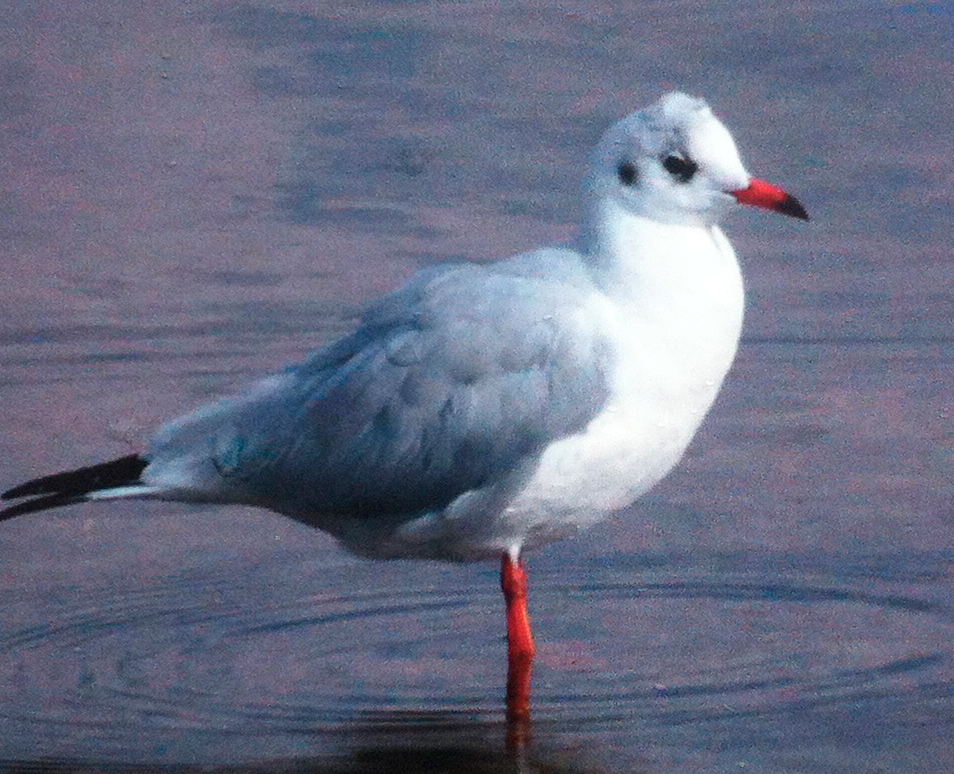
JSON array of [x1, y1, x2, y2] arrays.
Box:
[[512, 230, 743, 522]]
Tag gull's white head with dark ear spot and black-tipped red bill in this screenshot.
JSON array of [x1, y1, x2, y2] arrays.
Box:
[[589, 91, 807, 226]]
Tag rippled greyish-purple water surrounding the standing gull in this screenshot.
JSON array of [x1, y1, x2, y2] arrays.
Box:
[[0, 0, 954, 774]]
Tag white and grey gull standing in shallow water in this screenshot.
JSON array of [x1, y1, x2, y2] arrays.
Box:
[[0, 92, 808, 719]]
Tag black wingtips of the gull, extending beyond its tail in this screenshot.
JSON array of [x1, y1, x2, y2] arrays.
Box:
[[0, 454, 149, 520]]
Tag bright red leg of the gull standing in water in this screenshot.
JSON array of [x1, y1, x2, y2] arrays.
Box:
[[500, 554, 536, 722]]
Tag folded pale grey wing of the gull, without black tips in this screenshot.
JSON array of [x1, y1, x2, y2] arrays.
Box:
[[150, 256, 609, 515]]
